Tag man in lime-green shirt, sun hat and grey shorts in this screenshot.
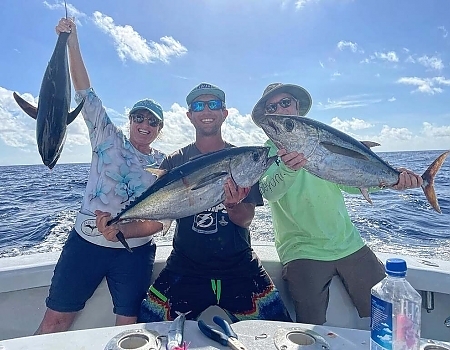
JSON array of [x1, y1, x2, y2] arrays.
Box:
[[252, 83, 422, 325]]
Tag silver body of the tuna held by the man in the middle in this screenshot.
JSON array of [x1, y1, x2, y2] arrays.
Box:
[[109, 147, 275, 224]]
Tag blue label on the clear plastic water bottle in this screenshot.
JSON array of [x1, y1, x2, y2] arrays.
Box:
[[370, 295, 392, 350]]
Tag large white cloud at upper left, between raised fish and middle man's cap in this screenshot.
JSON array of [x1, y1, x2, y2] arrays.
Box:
[[93, 11, 187, 63]]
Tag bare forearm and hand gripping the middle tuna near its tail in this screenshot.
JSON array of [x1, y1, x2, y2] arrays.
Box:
[[95, 210, 163, 242]]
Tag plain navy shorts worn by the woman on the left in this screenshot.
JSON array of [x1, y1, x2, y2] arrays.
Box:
[[46, 229, 156, 317]]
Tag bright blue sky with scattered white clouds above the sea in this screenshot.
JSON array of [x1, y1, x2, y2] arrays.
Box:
[[0, 0, 450, 165]]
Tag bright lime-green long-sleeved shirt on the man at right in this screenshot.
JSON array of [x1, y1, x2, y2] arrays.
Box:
[[260, 140, 364, 264]]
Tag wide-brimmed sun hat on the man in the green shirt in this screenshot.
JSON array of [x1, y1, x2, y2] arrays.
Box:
[[252, 84, 312, 126]]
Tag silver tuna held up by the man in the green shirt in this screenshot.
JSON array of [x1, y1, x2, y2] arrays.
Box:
[[260, 114, 449, 213]]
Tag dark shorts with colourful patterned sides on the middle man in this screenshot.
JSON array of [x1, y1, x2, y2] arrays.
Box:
[[138, 269, 292, 322]]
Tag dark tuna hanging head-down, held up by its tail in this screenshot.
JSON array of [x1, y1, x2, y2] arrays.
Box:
[[13, 9, 84, 169]]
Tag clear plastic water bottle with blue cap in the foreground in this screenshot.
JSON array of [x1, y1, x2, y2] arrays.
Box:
[[370, 259, 422, 350]]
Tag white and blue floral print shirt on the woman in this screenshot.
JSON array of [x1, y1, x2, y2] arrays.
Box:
[[75, 88, 164, 247]]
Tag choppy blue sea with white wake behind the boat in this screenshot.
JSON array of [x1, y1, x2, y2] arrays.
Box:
[[0, 151, 450, 260]]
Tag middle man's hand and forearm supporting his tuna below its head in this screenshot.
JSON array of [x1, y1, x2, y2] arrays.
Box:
[[223, 179, 256, 228]]
